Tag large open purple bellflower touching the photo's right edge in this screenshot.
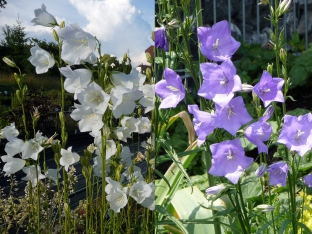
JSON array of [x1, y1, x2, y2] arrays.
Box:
[[277, 113, 312, 156]]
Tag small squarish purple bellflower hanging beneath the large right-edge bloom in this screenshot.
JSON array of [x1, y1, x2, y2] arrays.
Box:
[[268, 161, 288, 186]]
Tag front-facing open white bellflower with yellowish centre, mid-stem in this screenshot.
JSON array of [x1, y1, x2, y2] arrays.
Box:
[[77, 82, 110, 114]]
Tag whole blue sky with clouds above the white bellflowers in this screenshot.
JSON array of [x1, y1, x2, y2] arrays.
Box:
[[0, 0, 155, 65]]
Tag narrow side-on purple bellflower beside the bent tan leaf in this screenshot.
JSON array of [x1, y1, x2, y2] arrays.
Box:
[[188, 105, 215, 146]]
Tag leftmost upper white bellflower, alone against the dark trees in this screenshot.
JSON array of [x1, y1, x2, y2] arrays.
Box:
[[28, 44, 55, 74]]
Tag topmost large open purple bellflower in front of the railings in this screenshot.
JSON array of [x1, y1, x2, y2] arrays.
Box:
[[197, 20, 240, 61]]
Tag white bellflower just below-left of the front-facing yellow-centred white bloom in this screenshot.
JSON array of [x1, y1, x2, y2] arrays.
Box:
[[70, 104, 104, 135]]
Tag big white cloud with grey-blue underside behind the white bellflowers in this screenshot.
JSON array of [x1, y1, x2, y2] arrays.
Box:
[[69, 0, 152, 65]]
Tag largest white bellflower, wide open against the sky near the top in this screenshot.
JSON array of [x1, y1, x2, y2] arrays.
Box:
[[57, 24, 96, 65]]
